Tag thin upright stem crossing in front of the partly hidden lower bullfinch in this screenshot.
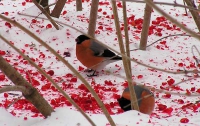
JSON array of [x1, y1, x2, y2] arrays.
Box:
[[111, 1, 140, 111]]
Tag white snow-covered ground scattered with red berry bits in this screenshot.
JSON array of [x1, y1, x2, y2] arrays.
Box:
[[0, 0, 200, 126]]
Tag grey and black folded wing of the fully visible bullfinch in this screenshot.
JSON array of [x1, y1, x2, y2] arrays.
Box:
[[90, 41, 115, 57]]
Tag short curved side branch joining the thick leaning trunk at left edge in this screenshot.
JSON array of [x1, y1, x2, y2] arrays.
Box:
[[0, 86, 32, 95]]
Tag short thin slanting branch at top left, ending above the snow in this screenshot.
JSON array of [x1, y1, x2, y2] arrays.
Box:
[[33, 0, 59, 30]]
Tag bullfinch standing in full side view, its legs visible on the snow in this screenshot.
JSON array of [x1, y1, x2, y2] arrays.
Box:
[[75, 35, 122, 77]]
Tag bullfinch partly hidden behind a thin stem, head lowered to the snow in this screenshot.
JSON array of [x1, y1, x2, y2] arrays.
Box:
[[117, 85, 155, 115]]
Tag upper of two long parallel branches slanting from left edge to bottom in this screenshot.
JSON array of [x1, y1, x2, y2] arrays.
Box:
[[0, 14, 114, 124]]
